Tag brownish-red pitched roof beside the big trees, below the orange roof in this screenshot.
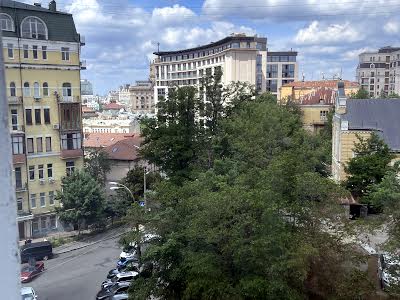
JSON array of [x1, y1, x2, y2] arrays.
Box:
[[104, 138, 141, 161]]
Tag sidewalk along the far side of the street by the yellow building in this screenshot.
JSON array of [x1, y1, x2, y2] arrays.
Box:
[[19, 226, 129, 254]]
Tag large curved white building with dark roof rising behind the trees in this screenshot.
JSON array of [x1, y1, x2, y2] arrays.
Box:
[[152, 34, 267, 104]]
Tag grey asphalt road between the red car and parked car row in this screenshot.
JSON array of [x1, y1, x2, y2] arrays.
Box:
[[23, 238, 121, 300]]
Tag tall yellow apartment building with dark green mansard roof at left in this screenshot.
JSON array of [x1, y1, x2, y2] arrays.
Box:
[[0, 0, 84, 239]]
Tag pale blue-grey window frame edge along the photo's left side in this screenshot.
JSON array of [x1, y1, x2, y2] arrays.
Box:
[[0, 31, 21, 299]]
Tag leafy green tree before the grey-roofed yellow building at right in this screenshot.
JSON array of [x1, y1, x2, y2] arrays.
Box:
[[345, 133, 393, 200]]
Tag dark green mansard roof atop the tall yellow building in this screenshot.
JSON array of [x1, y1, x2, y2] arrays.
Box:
[[0, 0, 80, 42]]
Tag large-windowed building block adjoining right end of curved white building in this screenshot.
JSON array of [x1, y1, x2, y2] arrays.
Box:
[[266, 51, 299, 99]]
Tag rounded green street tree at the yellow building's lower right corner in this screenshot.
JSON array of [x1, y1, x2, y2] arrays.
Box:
[[56, 171, 105, 231]]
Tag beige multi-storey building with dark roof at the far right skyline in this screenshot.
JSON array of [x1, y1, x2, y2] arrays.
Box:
[[356, 47, 400, 98]]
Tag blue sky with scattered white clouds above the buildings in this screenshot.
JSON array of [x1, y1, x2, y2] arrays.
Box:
[[24, 0, 400, 95]]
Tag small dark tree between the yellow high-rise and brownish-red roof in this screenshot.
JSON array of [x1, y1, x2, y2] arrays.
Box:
[[85, 149, 111, 186]]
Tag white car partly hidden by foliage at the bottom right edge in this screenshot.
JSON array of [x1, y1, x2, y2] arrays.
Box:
[[378, 253, 400, 290]]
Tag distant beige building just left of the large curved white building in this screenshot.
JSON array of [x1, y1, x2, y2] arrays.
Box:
[[129, 81, 154, 113]]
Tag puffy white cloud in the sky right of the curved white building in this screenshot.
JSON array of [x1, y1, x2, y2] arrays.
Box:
[[294, 21, 363, 45]]
